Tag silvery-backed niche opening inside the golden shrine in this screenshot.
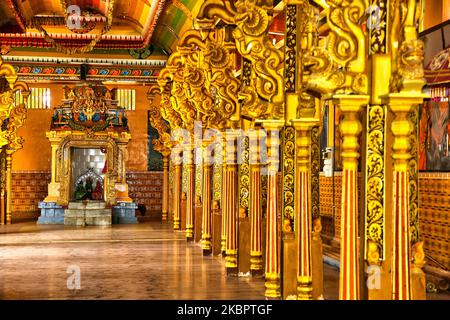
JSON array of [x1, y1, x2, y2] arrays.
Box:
[[70, 147, 106, 201]]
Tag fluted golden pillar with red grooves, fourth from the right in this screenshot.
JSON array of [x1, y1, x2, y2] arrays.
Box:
[[261, 120, 284, 299]]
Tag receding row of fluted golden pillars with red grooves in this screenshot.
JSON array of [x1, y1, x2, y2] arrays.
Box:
[[157, 94, 420, 300]]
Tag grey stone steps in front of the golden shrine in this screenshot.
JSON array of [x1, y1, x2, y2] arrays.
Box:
[[64, 201, 112, 226]]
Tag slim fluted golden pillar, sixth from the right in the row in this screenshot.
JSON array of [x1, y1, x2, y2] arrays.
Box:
[[224, 132, 239, 275]]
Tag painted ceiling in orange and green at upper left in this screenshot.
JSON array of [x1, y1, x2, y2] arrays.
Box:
[[0, 0, 199, 52]]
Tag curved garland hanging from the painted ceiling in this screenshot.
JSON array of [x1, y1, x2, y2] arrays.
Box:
[[31, 0, 115, 55]]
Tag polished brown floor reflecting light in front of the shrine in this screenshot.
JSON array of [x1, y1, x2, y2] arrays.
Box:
[[0, 221, 441, 300]]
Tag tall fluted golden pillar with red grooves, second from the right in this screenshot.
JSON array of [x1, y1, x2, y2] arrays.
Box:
[[333, 95, 369, 300]]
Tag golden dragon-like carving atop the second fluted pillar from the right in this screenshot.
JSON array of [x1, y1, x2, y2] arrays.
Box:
[[304, 0, 368, 95]]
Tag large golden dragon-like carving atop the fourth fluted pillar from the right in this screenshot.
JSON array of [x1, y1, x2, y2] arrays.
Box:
[[197, 0, 284, 119]]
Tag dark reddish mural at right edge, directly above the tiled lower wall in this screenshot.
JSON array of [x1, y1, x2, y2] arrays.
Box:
[[419, 100, 450, 171]]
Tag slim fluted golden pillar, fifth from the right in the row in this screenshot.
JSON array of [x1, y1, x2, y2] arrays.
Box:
[[249, 130, 263, 276]]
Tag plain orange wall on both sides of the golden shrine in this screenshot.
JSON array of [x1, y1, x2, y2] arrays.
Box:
[[12, 83, 149, 171]]
